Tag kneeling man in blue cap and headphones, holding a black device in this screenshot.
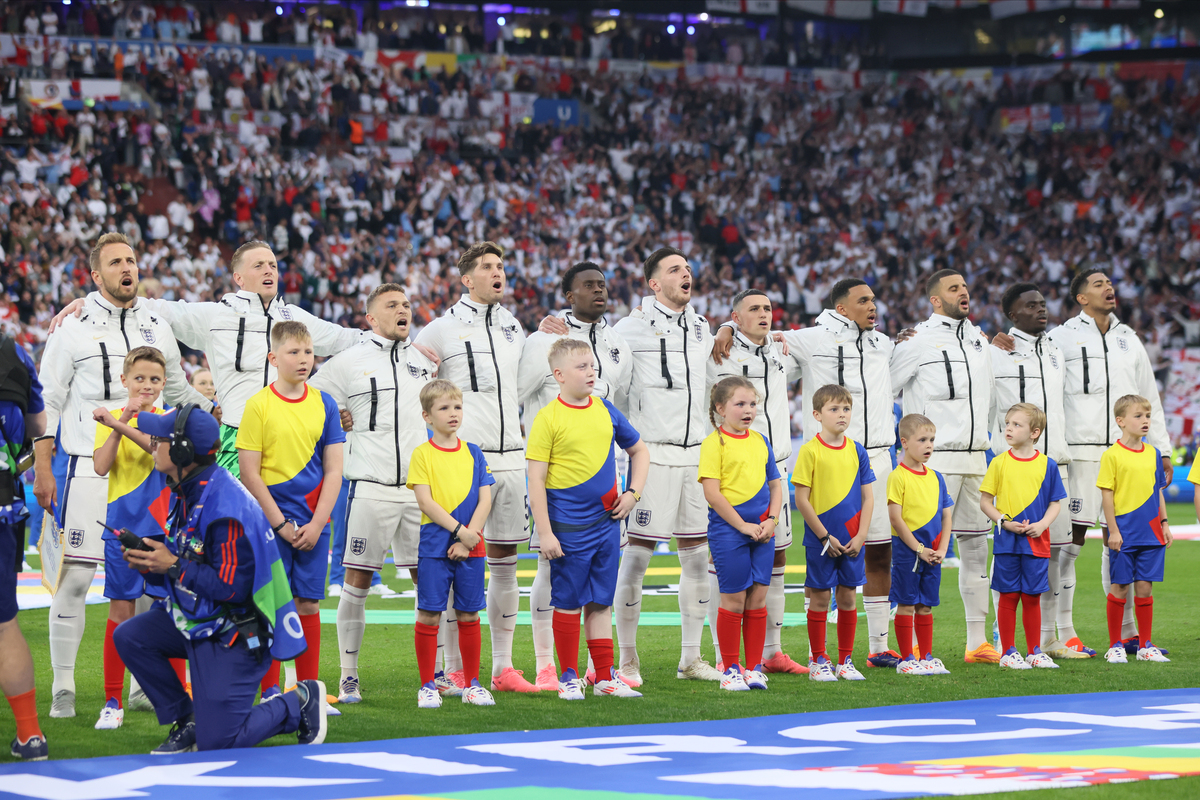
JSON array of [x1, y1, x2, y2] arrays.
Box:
[[113, 404, 326, 753]]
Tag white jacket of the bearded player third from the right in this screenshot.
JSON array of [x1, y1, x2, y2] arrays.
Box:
[[892, 314, 992, 475]]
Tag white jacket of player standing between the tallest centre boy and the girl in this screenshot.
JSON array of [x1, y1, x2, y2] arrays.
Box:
[[616, 296, 713, 467]]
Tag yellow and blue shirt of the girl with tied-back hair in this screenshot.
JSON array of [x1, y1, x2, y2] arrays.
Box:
[[700, 428, 780, 533]]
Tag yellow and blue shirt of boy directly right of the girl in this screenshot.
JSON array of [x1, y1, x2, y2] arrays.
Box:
[[792, 433, 875, 547]]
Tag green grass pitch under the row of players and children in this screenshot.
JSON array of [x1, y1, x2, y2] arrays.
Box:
[[0, 504, 1200, 800]]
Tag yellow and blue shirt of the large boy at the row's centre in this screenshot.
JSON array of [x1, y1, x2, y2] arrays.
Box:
[[526, 396, 641, 542]]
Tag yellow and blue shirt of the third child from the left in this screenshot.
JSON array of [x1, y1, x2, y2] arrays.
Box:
[[407, 439, 496, 559]]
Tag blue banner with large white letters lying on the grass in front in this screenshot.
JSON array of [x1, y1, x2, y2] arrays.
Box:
[[0, 690, 1200, 800]]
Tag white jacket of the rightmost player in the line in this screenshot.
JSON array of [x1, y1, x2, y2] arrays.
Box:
[[1049, 313, 1171, 461]]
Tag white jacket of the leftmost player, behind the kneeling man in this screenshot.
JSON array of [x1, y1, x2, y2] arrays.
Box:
[[37, 291, 212, 458]]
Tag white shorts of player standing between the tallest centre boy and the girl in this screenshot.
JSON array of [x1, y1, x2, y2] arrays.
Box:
[[625, 464, 708, 542]]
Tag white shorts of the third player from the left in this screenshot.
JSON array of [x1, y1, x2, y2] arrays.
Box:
[[342, 481, 421, 572]]
